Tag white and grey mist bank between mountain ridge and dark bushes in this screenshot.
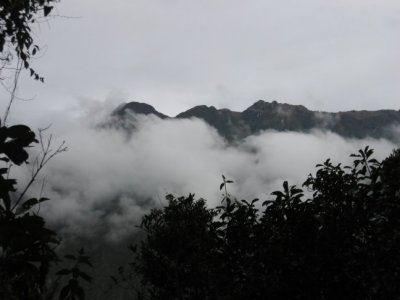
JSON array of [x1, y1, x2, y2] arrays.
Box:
[[14, 101, 396, 242]]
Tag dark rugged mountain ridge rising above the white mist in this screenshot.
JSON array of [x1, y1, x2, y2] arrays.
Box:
[[113, 100, 400, 141]]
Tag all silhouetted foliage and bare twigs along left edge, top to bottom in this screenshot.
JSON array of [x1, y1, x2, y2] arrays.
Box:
[[0, 0, 86, 299]]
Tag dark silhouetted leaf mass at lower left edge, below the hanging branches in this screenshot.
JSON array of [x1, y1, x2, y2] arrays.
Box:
[[0, 121, 58, 299]]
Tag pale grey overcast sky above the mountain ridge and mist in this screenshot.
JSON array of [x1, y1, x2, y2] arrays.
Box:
[[0, 0, 400, 124]]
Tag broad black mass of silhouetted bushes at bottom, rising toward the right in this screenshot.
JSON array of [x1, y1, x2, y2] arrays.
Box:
[[131, 147, 400, 299]]
